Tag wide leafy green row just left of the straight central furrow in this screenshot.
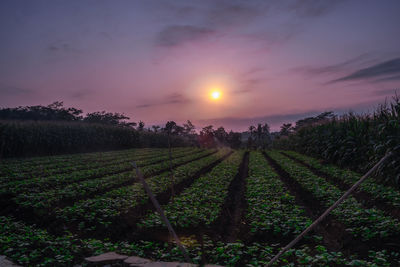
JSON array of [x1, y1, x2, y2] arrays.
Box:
[[139, 152, 243, 228]]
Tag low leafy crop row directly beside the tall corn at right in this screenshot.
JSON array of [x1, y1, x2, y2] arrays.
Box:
[[285, 151, 400, 208]]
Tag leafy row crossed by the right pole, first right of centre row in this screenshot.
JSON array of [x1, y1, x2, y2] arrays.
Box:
[[267, 151, 400, 243]]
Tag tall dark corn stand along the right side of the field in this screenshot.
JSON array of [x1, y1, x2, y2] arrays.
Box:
[[274, 96, 400, 185]]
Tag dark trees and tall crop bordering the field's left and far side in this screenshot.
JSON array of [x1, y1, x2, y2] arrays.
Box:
[[0, 102, 242, 157]]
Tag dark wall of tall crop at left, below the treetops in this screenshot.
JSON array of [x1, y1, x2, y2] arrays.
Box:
[[0, 120, 188, 157]]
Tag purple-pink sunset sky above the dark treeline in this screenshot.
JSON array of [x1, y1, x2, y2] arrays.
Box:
[[0, 0, 400, 131]]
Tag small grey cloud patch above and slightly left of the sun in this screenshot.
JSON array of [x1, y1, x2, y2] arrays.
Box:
[[156, 25, 215, 47]]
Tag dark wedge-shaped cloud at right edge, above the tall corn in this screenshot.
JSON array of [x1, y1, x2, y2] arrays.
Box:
[[330, 58, 400, 83]]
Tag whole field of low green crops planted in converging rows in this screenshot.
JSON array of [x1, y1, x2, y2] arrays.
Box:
[[0, 147, 400, 266]]
